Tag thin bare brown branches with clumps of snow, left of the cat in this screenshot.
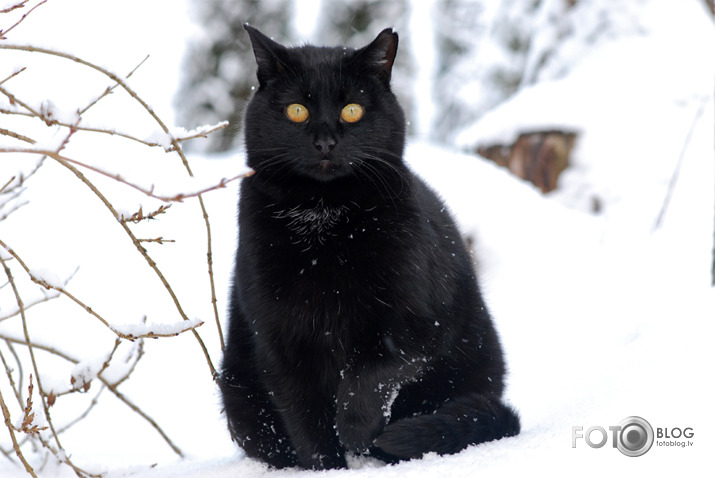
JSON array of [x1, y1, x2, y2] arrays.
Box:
[[0, 7, 238, 470]]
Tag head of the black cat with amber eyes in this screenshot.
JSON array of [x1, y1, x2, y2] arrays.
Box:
[[245, 25, 405, 188]]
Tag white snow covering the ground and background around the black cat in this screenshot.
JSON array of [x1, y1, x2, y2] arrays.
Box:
[[0, 0, 715, 478]]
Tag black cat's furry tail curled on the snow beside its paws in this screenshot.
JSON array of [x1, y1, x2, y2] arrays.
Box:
[[375, 393, 521, 460]]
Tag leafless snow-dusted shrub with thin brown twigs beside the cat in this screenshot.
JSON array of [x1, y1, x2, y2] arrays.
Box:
[[0, 0, 242, 477]]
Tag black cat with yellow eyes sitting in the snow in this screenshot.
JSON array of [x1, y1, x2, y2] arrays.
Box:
[[220, 25, 520, 469]]
